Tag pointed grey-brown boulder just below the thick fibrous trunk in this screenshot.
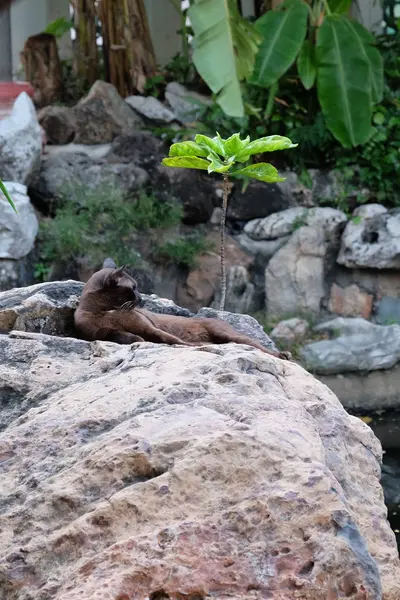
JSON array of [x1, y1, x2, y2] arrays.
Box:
[[73, 81, 143, 144]]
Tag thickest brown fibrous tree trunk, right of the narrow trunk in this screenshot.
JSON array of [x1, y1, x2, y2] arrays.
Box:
[[99, 0, 156, 97]]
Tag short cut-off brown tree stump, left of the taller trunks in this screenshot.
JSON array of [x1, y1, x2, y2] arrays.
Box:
[[21, 33, 63, 107]]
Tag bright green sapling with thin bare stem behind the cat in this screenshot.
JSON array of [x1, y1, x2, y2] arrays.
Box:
[[162, 132, 297, 310]]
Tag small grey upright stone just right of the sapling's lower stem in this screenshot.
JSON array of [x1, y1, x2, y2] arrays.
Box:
[[211, 265, 255, 313]]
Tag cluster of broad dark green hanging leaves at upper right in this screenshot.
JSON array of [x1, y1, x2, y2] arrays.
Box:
[[249, 0, 384, 148]]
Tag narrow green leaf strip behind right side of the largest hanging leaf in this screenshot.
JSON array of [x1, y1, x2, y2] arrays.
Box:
[[344, 19, 384, 103]]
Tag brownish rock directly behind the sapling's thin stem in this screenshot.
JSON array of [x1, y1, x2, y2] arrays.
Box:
[[177, 232, 252, 311]]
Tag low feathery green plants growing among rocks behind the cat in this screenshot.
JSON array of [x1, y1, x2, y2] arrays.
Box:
[[35, 186, 205, 280]]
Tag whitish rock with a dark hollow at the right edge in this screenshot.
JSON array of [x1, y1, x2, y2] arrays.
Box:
[[337, 209, 400, 269]]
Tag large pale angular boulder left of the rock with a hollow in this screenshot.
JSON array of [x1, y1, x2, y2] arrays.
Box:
[[266, 208, 346, 317]]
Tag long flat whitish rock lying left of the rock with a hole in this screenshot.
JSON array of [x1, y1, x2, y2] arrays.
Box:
[[244, 206, 347, 240]]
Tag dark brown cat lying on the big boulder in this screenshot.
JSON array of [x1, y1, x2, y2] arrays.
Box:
[[75, 263, 290, 360]]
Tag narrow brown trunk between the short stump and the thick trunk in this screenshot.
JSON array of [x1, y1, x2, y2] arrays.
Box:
[[72, 0, 99, 85]]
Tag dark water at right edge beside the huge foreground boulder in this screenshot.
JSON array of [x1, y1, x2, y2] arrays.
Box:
[[349, 410, 400, 551]]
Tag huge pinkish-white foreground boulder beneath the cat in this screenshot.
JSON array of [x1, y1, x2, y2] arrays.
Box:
[[0, 316, 400, 600]]
